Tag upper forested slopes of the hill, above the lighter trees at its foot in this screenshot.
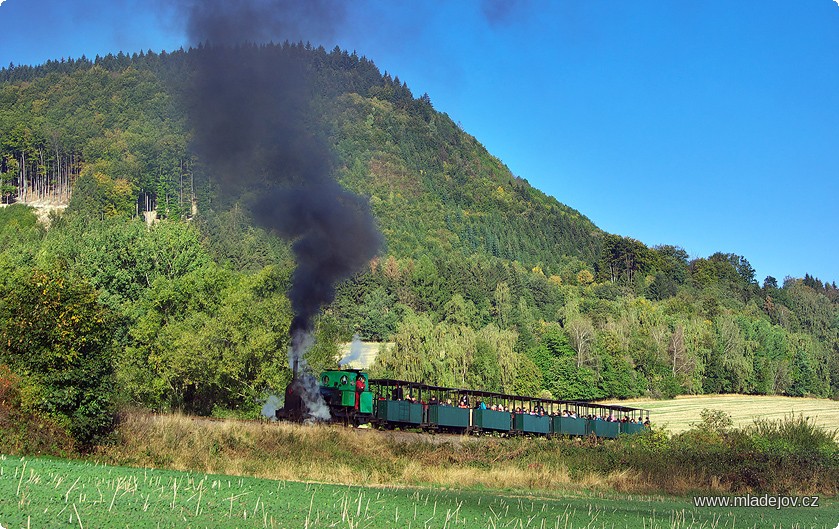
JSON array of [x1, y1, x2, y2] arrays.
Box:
[[0, 46, 602, 271]]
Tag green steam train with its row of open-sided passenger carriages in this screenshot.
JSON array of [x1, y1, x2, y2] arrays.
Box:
[[276, 369, 649, 438]]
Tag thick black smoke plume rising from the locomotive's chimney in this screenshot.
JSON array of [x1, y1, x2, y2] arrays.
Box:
[[181, 0, 381, 418]]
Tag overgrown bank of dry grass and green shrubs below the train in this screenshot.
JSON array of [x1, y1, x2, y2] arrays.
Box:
[[96, 406, 839, 496]]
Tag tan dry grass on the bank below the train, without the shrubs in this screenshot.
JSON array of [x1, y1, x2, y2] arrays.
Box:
[[99, 413, 596, 490]]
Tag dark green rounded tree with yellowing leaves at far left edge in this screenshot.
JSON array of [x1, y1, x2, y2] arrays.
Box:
[[0, 271, 114, 449]]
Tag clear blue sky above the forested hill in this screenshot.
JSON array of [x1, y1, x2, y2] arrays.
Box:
[[0, 0, 839, 281]]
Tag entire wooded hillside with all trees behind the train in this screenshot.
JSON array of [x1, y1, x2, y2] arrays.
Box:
[[0, 44, 839, 438]]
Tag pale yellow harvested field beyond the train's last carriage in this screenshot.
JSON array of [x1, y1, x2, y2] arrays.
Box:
[[604, 395, 839, 433]]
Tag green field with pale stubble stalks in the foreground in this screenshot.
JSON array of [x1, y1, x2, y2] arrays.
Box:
[[0, 456, 839, 529]]
